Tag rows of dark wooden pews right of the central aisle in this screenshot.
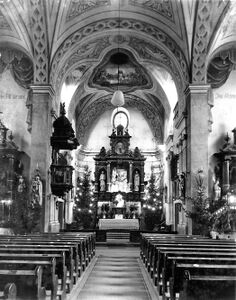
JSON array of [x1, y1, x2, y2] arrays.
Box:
[[140, 234, 236, 300]]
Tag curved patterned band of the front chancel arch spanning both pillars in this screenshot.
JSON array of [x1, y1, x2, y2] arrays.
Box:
[[50, 18, 189, 83]]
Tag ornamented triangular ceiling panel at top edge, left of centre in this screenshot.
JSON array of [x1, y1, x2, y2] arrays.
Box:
[[66, 0, 111, 22]]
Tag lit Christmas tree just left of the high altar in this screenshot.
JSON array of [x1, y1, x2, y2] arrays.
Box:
[[74, 166, 96, 229]]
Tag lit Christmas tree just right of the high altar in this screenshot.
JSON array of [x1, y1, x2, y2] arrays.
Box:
[[143, 170, 163, 230]]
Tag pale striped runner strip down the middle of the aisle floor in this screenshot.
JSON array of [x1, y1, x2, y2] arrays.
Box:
[[78, 255, 151, 300]]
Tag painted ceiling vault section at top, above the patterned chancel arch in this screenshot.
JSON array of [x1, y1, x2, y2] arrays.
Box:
[[52, 0, 188, 58]]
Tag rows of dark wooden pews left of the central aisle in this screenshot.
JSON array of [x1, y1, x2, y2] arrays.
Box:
[[0, 232, 95, 300]]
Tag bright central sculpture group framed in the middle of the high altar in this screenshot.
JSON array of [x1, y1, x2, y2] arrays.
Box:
[[111, 167, 128, 193]]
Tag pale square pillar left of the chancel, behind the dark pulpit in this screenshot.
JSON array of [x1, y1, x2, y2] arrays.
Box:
[[30, 85, 55, 232]]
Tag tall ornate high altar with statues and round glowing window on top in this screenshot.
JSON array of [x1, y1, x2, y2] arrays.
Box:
[[94, 109, 145, 223]]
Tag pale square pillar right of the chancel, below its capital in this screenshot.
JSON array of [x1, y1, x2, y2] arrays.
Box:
[[185, 84, 212, 234]]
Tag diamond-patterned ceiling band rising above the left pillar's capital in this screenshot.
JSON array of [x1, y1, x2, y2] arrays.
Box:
[[30, 0, 49, 84]]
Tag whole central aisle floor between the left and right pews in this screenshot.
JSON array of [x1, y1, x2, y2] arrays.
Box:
[[76, 247, 158, 300]]
